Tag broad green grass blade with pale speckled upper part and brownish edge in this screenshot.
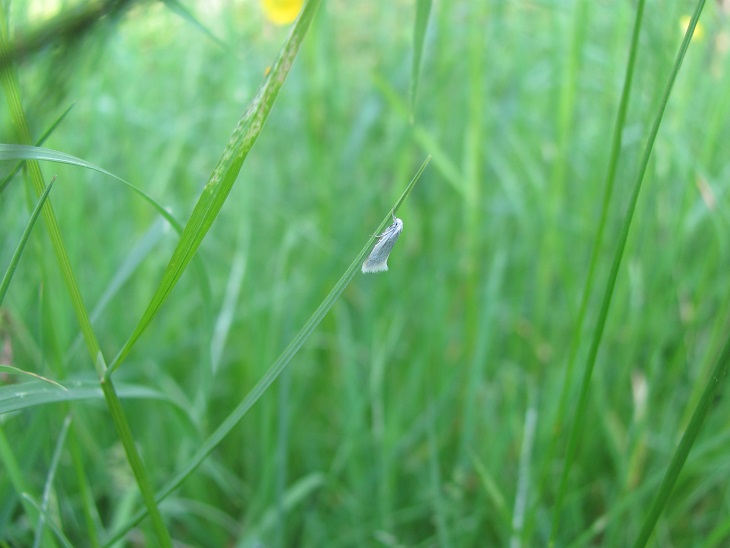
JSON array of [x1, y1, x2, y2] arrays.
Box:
[[106, 0, 321, 377]]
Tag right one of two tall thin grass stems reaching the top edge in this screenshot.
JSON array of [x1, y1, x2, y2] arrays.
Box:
[[550, 0, 705, 546]]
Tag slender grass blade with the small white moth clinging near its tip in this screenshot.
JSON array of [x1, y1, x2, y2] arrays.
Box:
[[105, 156, 431, 546]]
